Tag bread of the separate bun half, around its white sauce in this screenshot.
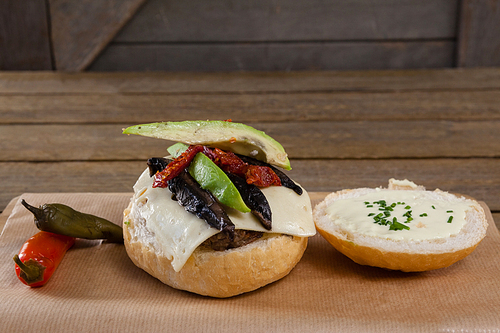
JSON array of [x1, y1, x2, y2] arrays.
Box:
[[313, 179, 488, 272]]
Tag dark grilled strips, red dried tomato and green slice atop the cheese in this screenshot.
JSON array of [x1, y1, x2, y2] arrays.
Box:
[[135, 126, 302, 232]]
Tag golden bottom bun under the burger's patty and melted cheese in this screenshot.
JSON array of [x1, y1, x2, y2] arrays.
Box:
[[123, 201, 307, 298]]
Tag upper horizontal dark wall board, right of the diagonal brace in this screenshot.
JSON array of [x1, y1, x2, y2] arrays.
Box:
[[115, 0, 458, 43]]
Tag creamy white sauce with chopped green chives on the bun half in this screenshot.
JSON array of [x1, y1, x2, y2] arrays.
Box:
[[326, 188, 472, 241]]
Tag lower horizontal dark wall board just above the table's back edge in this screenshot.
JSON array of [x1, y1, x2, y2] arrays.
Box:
[[88, 41, 455, 72]]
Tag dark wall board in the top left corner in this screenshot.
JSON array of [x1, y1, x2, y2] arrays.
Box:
[[0, 0, 52, 70]]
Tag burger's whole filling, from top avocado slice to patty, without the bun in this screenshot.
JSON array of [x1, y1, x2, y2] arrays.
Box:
[[123, 121, 315, 270]]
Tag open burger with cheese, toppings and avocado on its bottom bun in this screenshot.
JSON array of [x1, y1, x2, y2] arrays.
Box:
[[123, 121, 316, 298]]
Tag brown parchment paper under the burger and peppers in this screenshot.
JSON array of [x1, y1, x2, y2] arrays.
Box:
[[0, 193, 500, 332]]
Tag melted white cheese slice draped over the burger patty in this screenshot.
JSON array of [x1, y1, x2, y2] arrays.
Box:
[[131, 169, 316, 272]]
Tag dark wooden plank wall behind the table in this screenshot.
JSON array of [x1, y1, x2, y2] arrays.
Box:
[[0, 0, 500, 71]]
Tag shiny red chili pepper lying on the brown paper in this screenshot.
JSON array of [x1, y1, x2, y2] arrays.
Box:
[[14, 231, 75, 287]]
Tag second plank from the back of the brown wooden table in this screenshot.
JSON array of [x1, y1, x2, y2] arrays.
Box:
[[0, 89, 500, 124]]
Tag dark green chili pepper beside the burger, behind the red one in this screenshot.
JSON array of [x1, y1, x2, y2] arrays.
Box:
[[21, 200, 123, 243]]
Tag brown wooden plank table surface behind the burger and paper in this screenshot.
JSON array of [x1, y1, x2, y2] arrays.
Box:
[[0, 68, 500, 226]]
